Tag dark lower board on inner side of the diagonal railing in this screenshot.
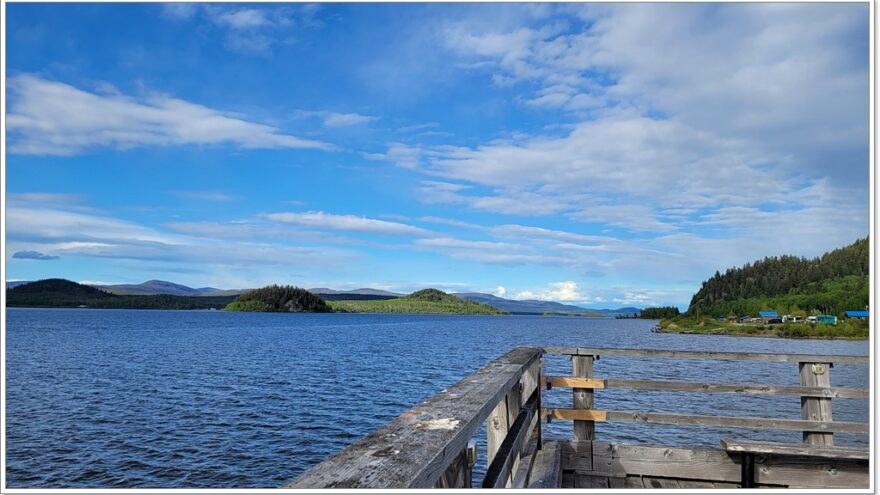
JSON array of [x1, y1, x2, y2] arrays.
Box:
[[482, 388, 541, 488]]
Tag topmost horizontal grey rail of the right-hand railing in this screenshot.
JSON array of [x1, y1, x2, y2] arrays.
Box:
[[543, 347, 870, 364]]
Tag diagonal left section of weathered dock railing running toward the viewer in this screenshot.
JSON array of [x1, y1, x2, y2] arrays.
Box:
[[284, 347, 542, 488]]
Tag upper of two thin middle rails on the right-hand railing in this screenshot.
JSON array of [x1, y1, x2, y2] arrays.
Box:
[[604, 377, 871, 399]]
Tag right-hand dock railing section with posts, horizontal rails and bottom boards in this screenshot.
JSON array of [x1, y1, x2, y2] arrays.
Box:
[[542, 347, 870, 488]]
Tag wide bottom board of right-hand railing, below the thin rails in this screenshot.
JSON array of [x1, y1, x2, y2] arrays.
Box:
[[562, 442, 869, 488]]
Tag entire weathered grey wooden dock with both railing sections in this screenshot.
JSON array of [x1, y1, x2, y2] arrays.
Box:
[[284, 347, 870, 489]]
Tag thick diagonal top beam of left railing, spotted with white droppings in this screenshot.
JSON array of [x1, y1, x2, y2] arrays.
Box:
[[284, 348, 540, 488]]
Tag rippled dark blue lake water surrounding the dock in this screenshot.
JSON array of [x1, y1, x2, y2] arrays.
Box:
[[6, 309, 868, 488]]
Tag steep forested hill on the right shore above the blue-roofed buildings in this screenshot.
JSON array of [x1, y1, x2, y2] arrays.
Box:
[[688, 238, 870, 316]]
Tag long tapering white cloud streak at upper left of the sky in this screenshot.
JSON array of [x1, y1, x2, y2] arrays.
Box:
[[6, 74, 333, 155]]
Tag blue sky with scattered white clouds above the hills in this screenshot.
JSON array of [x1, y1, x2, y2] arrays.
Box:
[[5, 3, 870, 308]]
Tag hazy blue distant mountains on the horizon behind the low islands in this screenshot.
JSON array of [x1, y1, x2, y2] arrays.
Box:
[[6, 280, 641, 316]]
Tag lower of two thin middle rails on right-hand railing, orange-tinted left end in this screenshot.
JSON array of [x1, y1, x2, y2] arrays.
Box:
[[546, 408, 869, 433]]
